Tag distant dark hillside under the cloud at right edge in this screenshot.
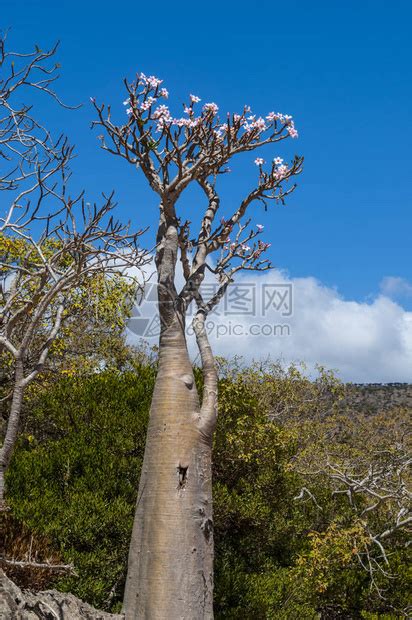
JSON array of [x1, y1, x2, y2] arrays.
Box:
[[345, 383, 412, 413]]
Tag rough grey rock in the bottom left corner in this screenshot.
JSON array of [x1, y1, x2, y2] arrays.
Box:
[[0, 569, 124, 620]]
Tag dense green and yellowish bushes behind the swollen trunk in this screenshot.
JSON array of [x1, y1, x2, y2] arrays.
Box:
[[7, 360, 410, 620]]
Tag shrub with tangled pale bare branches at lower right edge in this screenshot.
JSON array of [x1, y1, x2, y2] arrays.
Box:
[[295, 409, 412, 617]]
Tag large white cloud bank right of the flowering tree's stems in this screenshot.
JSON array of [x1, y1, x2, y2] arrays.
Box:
[[126, 270, 412, 382]]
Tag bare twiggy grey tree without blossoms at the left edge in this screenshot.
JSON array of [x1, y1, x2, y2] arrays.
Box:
[[0, 38, 147, 506]]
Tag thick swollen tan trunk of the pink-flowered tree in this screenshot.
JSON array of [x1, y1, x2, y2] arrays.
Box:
[[123, 315, 213, 620]]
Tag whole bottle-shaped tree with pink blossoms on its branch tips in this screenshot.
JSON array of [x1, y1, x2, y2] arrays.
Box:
[[92, 74, 302, 619]]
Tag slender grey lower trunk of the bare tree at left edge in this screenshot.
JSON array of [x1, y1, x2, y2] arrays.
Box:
[[0, 360, 24, 510]]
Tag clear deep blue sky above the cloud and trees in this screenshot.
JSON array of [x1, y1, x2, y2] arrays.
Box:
[[0, 0, 412, 380]]
